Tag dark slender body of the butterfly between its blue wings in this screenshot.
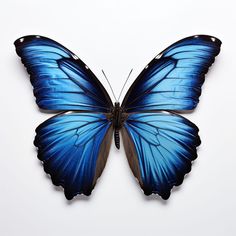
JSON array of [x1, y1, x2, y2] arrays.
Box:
[[112, 102, 125, 149]]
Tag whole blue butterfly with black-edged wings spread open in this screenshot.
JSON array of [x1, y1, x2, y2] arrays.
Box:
[[14, 35, 221, 200]]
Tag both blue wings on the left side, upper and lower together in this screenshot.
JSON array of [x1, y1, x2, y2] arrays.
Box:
[[15, 36, 113, 199]]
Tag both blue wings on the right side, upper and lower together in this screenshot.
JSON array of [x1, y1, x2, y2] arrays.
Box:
[[122, 35, 221, 199]]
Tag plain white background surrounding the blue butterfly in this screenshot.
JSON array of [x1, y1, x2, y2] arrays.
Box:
[[0, 0, 236, 236]]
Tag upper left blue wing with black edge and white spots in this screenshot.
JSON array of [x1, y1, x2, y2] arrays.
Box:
[[15, 36, 112, 112]]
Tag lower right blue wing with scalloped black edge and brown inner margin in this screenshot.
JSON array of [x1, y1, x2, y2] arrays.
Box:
[[122, 112, 200, 199]]
